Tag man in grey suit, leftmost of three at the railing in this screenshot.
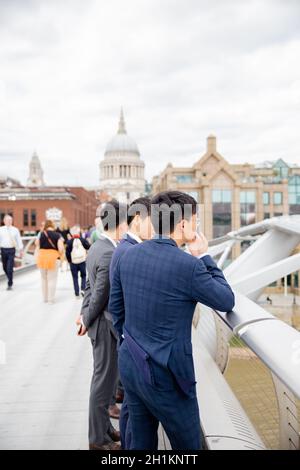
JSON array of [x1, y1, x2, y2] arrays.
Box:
[[77, 200, 128, 450]]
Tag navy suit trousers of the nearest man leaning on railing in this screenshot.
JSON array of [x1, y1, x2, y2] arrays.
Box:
[[119, 341, 201, 451]]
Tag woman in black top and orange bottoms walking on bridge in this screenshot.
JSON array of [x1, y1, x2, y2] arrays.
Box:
[[37, 220, 64, 304]]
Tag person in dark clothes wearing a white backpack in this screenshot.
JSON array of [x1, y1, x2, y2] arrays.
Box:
[[66, 225, 90, 298]]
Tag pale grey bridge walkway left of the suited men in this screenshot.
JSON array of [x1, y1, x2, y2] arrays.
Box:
[[0, 271, 92, 449]]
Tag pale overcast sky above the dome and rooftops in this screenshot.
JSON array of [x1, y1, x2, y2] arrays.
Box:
[[0, 0, 300, 186]]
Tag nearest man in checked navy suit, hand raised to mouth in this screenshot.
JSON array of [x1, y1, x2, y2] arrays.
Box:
[[109, 191, 234, 450]]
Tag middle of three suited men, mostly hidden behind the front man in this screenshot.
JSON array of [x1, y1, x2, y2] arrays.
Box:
[[109, 197, 153, 449]]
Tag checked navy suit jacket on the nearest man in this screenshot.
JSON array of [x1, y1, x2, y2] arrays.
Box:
[[109, 237, 234, 395]]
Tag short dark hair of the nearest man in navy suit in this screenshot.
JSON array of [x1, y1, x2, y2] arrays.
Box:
[[151, 191, 197, 235]]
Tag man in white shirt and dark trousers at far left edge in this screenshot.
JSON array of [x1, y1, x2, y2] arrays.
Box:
[[0, 214, 24, 290]]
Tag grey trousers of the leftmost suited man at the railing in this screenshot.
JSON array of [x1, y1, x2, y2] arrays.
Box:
[[89, 315, 118, 446]]
